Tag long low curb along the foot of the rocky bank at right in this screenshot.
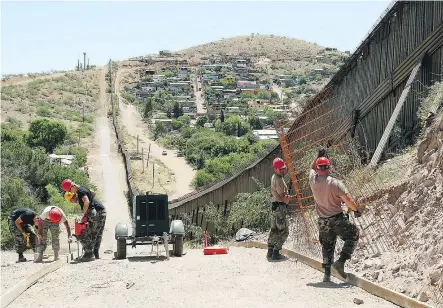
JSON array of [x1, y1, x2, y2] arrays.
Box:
[[229, 241, 433, 308]]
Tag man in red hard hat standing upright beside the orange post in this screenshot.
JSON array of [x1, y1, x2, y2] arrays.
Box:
[[267, 157, 296, 260]]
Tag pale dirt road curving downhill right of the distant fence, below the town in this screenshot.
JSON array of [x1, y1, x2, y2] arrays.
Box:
[[115, 71, 196, 200]]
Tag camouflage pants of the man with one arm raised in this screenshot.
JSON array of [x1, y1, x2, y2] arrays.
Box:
[[318, 214, 360, 268]]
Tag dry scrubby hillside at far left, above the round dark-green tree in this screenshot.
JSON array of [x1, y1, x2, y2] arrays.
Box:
[[1, 70, 100, 135]]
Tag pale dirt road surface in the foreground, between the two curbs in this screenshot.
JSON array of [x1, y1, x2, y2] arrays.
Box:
[[6, 248, 397, 308]]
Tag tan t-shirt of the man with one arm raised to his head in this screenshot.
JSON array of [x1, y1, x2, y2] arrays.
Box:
[[309, 169, 348, 218]]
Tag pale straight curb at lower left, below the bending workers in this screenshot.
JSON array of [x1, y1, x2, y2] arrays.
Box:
[[0, 251, 76, 308]]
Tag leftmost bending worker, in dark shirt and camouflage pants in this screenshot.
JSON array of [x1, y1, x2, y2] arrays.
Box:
[[8, 208, 40, 262]]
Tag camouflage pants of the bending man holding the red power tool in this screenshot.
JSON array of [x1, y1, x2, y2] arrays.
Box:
[[80, 209, 106, 253]]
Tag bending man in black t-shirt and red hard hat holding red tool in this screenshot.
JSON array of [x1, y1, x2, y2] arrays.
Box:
[[62, 179, 106, 261]]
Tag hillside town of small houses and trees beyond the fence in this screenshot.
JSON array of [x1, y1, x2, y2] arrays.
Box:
[[126, 48, 348, 140]]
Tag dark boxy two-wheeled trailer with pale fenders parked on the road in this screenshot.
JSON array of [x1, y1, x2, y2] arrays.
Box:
[[115, 192, 185, 259]]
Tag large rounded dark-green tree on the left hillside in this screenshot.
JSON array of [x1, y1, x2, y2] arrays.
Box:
[[27, 119, 68, 153]]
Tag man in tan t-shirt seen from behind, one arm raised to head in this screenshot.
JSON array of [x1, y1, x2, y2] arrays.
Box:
[[309, 149, 363, 282]]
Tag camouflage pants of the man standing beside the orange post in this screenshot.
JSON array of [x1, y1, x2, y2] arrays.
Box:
[[268, 203, 289, 250]]
